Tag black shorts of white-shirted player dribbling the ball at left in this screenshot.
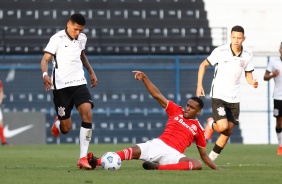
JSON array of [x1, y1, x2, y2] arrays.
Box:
[[53, 85, 94, 120]]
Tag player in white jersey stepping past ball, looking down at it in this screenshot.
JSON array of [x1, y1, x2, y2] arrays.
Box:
[[41, 13, 98, 169]]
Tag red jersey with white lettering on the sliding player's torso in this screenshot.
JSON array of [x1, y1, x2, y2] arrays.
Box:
[[159, 100, 206, 153]]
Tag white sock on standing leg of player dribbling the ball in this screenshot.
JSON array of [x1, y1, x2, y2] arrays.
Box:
[[79, 127, 92, 158]]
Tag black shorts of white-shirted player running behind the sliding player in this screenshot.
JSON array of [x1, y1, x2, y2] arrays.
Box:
[[212, 98, 240, 125]]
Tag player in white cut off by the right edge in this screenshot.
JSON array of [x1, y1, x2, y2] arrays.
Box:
[[263, 42, 282, 155]]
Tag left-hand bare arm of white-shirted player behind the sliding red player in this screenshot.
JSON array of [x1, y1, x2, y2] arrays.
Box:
[[196, 59, 210, 97]]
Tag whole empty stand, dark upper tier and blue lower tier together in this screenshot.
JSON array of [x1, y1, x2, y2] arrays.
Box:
[[0, 0, 242, 144]]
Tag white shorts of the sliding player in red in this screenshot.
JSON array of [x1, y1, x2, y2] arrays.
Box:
[[137, 138, 186, 165]]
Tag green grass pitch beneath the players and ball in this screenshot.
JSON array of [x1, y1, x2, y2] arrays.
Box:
[[0, 144, 282, 184]]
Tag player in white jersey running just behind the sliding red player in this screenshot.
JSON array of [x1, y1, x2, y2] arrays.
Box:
[[196, 25, 258, 161]]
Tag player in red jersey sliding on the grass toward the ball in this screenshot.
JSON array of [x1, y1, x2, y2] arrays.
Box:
[[88, 71, 218, 170]]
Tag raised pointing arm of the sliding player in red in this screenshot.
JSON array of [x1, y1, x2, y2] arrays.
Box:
[[132, 71, 168, 109]]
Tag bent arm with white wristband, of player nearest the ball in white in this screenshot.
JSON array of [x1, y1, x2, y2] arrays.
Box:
[[41, 52, 52, 91]]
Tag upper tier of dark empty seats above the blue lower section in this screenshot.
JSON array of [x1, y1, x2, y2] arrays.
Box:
[[0, 0, 218, 55]]
